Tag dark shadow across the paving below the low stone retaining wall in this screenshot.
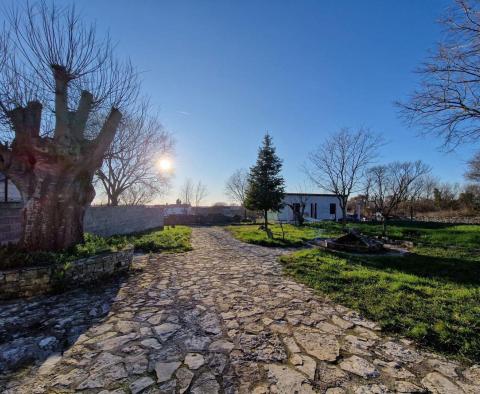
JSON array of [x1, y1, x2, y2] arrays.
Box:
[[0, 275, 127, 378]]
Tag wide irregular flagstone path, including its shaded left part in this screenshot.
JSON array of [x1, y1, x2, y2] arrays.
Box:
[[0, 228, 480, 394]]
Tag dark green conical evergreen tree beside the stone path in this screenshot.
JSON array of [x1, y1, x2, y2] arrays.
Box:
[[245, 133, 285, 232]]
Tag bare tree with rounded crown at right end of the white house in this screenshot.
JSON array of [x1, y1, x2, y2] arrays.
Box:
[[305, 128, 382, 225]]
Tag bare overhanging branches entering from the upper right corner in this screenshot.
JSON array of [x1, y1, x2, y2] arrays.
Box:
[[399, 0, 480, 146]]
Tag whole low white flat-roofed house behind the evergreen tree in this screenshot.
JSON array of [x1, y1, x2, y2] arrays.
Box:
[[272, 193, 342, 222]]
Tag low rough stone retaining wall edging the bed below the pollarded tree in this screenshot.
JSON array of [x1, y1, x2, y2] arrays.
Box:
[[0, 247, 133, 300]]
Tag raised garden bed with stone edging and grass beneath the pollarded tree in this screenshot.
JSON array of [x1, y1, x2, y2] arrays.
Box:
[[0, 226, 191, 299]]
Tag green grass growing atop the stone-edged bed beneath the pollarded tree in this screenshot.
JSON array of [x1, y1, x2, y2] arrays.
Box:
[[0, 226, 192, 269]]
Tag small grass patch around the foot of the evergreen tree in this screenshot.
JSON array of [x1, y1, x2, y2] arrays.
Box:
[[227, 224, 338, 247]]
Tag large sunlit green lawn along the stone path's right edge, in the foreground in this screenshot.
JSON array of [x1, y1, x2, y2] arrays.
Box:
[[281, 246, 480, 362]]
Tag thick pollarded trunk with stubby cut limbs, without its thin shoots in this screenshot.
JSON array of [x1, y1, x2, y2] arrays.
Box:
[[0, 66, 121, 251]]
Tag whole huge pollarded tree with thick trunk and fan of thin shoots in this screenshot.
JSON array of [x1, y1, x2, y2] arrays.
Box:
[[0, 2, 138, 250]]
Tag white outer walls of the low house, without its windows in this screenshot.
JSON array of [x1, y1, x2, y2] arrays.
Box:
[[277, 194, 342, 222]]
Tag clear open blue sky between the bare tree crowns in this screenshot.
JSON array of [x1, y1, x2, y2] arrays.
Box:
[[15, 0, 475, 203]]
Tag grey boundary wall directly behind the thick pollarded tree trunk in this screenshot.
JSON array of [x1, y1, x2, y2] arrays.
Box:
[[0, 204, 164, 245]]
